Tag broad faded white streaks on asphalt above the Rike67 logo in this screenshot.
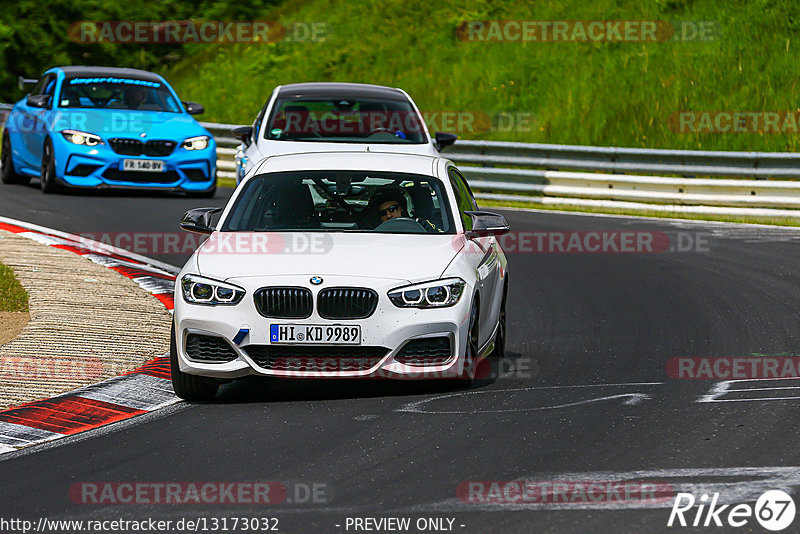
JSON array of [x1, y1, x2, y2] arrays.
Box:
[[413, 466, 800, 512]]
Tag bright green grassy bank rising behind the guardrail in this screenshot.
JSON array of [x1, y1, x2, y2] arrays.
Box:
[[166, 0, 800, 151]]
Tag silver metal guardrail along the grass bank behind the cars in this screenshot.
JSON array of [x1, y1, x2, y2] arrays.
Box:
[[0, 104, 800, 219]]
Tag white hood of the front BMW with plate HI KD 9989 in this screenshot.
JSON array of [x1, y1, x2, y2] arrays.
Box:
[[196, 232, 463, 283]]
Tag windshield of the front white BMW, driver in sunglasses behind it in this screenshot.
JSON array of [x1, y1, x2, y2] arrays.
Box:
[[222, 171, 455, 234]]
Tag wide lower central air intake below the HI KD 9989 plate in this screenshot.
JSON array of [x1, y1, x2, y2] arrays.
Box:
[[243, 345, 389, 373]]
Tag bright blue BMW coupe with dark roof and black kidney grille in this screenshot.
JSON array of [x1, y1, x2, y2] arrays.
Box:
[[0, 67, 217, 196]]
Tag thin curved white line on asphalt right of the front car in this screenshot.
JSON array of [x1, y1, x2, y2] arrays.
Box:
[[395, 382, 663, 414]]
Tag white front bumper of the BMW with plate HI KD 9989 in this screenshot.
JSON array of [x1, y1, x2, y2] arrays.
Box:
[[175, 275, 472, 379]]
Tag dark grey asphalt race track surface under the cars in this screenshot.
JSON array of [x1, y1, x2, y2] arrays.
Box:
[[0, 182, 800, 533]]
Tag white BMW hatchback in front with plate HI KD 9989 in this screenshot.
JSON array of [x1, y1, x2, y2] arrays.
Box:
[[171, 152, 508, 400]]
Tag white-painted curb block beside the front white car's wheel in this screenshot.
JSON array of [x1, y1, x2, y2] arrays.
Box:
[[77, 374, 180, 411]]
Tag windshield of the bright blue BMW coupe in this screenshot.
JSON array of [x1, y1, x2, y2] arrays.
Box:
[[58, 76, 181, 113]]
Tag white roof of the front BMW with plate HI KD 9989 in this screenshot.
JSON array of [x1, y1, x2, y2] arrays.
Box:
[[252, 151, 441, 176]]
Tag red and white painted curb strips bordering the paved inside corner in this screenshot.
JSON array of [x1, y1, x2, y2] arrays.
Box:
[[0, 217, 180, 454]]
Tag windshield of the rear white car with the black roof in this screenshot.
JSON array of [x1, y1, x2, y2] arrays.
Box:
[[264, 98, 427, 144]]
